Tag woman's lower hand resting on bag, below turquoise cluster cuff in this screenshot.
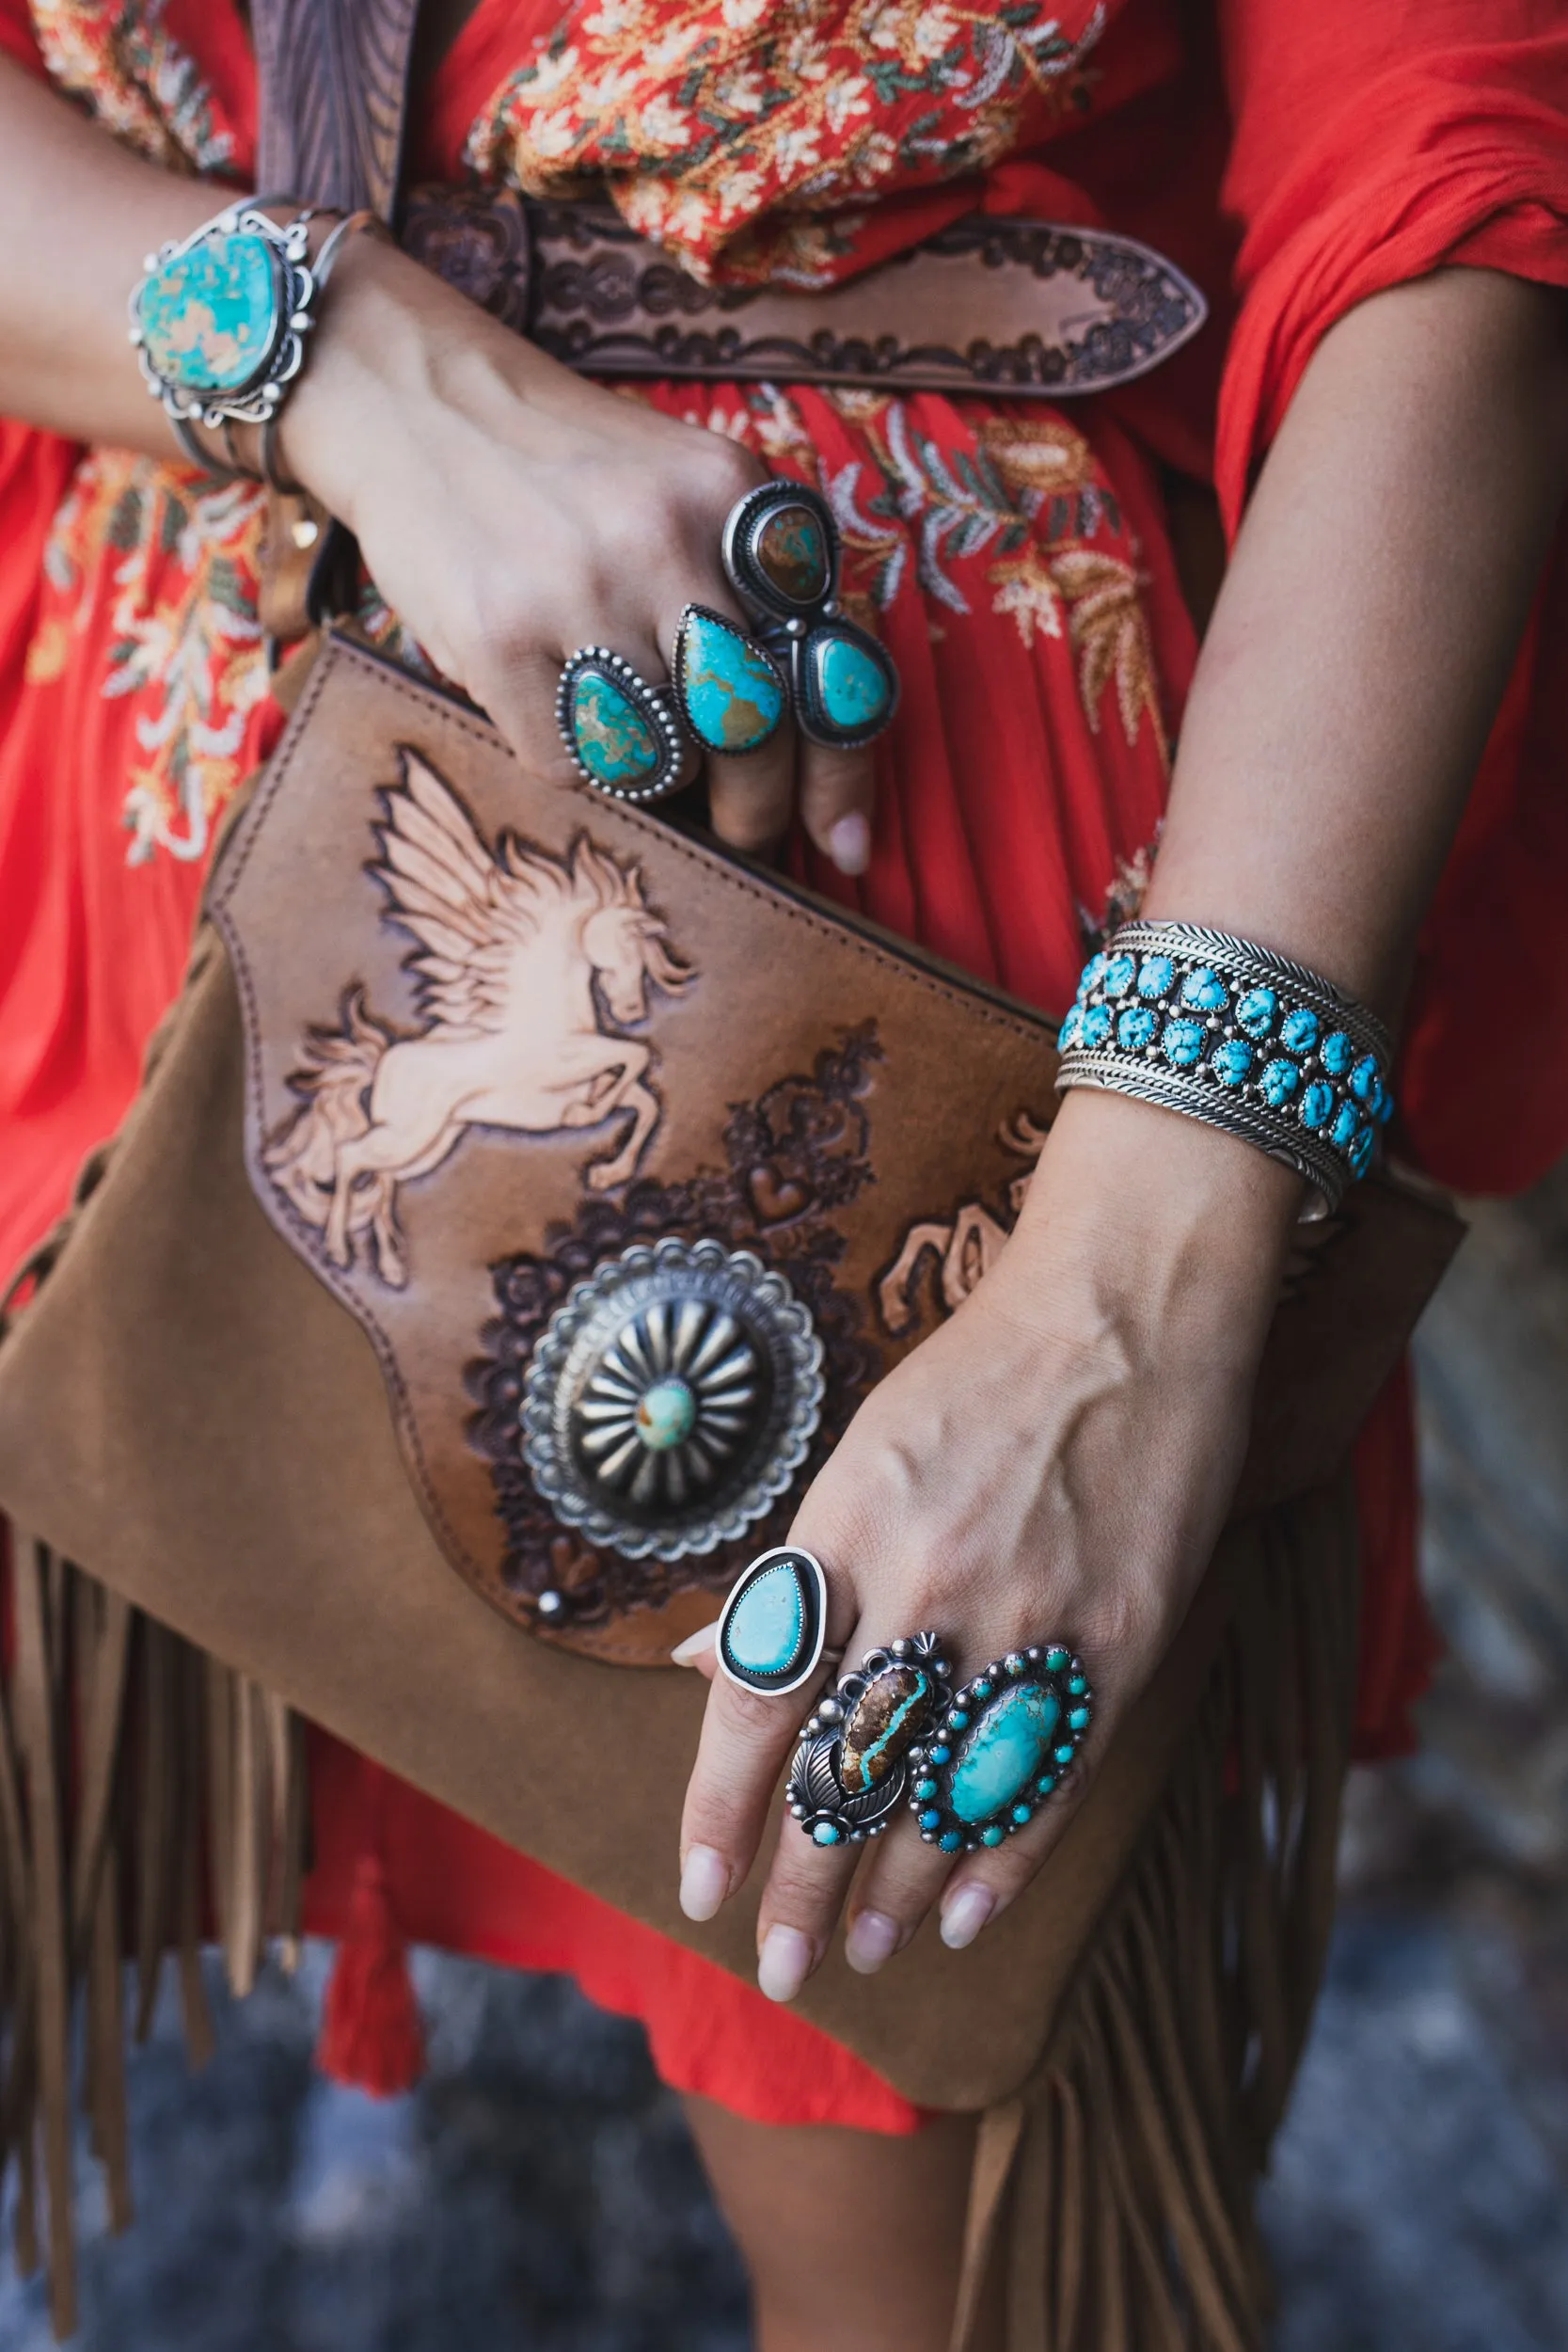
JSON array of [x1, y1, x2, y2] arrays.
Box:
[[682, 1094, 1300, 1999]]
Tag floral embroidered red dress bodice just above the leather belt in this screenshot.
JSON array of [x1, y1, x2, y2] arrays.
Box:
[[467, 0, 1107, 285]]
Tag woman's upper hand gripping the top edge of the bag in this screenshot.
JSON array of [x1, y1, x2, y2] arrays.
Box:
[[279, 238, 872, 873]]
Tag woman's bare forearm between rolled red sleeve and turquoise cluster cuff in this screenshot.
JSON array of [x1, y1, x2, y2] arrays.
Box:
[[1148, 271, 1568, 1019]]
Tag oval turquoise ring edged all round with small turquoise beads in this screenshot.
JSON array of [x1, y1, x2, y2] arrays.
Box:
[[908, 1642, 1093, 1853]]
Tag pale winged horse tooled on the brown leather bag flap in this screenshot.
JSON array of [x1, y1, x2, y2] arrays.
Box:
[[265, 751, 696, 1289]]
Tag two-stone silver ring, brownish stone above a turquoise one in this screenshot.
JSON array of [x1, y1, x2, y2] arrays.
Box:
[[721, 480, 898, 751]]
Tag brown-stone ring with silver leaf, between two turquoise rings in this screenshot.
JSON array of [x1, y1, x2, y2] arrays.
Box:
[[787, 1632, 952, 1847]]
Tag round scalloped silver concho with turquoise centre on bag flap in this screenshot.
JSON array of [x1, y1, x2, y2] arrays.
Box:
[[522, 1240, 823, 1560]]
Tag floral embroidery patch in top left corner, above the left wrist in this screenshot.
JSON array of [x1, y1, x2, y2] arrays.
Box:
[[28, 0, 235, 172]]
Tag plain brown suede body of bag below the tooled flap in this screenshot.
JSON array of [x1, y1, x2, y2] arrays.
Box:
[[0, 635, 1458, 2107]]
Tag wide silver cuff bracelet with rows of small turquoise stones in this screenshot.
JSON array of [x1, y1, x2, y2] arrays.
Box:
[[1055, 922, 1394, 1216]]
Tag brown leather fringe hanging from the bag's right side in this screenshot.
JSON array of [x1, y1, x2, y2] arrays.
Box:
[[952, 1482, 1359, 2352]]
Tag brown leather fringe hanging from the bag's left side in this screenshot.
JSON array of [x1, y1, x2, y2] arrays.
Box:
[[0, 1529, 308, 2338]]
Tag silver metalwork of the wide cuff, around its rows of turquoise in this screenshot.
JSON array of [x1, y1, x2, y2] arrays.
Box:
[[1055, 922, 1394, 1223]]
